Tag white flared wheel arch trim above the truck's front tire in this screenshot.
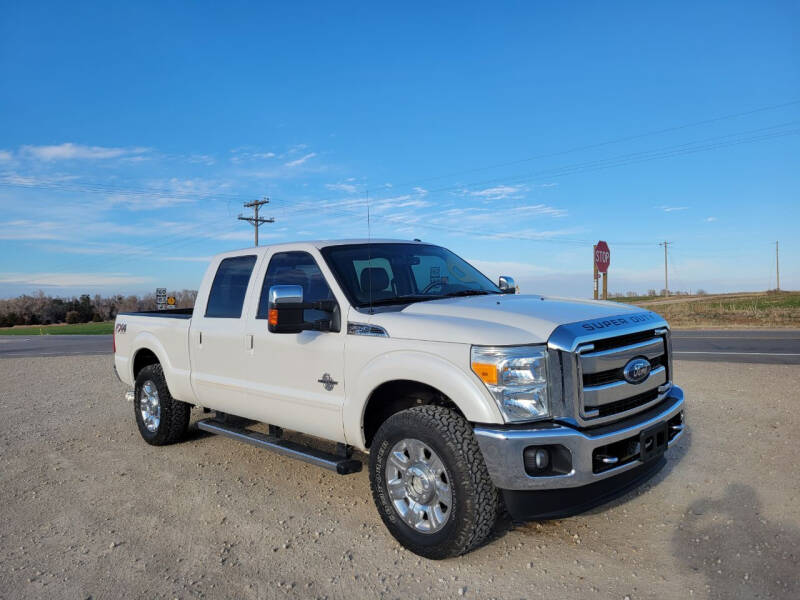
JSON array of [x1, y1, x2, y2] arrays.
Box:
[[343, 350, 503, 449]]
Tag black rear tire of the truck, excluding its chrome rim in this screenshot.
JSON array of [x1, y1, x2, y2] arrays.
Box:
[[133, 364, 192, 446]]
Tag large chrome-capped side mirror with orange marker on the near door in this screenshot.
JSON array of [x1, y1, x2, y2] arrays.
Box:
[[267, 285, 339, 333]]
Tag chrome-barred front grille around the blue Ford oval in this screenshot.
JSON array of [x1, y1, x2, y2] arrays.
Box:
[[576, 329, 671, 424]]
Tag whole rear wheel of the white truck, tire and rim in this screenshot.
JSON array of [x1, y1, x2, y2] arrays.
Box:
[[133, 364, 191, 446]]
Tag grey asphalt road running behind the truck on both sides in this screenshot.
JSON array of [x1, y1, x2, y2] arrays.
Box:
[[0, 329, 800, 365]]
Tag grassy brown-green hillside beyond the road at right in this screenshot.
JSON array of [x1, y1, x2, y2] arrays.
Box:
[[613, 292, 800, 328]]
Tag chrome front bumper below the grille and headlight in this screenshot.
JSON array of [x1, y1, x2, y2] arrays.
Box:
[[474, 386, 684, 490]]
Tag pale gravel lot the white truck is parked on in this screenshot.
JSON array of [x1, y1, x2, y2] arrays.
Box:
[[0, 356, 800, 600]]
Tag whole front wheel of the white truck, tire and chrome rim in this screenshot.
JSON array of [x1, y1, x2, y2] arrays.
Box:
[[369, 406, 499, 559]]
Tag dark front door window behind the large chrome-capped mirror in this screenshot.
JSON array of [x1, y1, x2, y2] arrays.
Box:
[[256, 251, 334, 321]]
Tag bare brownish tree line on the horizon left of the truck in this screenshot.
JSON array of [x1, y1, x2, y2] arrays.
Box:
[[0, 290, 197, 327]]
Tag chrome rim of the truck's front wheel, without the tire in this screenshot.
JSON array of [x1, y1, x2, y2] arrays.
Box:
[[386, 438, 453, 533]]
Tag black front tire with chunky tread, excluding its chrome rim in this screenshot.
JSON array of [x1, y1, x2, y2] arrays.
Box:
[[369, 405, 499, 560]]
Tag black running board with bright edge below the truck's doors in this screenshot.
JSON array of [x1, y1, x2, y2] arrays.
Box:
[[197, 419, 361, 475]]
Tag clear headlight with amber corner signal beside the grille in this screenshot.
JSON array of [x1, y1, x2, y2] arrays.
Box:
[[471, 346, 550, 422]]
